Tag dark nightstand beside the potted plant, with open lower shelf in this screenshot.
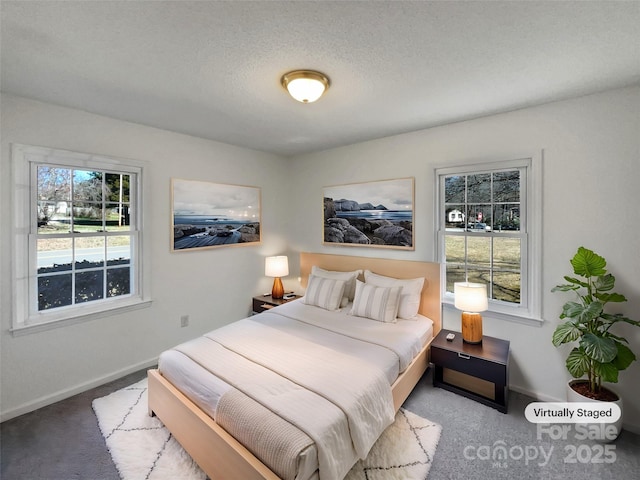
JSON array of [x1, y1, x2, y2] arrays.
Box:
[[431, 330, 509, 413]]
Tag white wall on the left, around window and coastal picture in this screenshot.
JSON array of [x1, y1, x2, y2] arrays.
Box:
[[0, 94, 288, 419]]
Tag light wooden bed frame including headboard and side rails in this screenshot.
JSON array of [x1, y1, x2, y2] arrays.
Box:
[[148, 253, 442, 480]]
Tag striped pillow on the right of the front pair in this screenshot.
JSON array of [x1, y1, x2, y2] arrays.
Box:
[[351, 280, 402, 323]]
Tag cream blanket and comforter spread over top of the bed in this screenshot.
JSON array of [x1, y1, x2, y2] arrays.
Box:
[[160, 302, 436, 480]]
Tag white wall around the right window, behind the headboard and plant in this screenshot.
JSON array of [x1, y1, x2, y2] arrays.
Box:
[[291, 87, 640, 431]]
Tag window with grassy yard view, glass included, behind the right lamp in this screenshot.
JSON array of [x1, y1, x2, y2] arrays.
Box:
[[436, 158, 541, 320]]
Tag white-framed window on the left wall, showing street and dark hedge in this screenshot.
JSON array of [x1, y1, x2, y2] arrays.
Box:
[[13, 145, 150, 330]]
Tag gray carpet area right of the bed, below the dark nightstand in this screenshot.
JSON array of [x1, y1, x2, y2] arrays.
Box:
[[404, 373, 640, 480]]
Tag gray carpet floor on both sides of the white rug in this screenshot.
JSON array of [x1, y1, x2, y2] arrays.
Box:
[[0, 366, 640, 480]]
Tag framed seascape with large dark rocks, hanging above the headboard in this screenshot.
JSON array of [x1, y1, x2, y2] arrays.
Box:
[[322, 177, 415, 250]]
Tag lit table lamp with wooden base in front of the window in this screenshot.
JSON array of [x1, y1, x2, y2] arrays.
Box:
[[453, 282, 489, 343]]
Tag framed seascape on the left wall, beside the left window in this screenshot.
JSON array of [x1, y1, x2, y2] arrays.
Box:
[[171, 178, 261, 251]]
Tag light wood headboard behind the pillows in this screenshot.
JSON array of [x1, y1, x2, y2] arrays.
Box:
[[300, 252, 442, 336]]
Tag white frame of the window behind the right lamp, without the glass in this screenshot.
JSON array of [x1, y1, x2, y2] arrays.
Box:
[[434, 151, 544, 326]]
